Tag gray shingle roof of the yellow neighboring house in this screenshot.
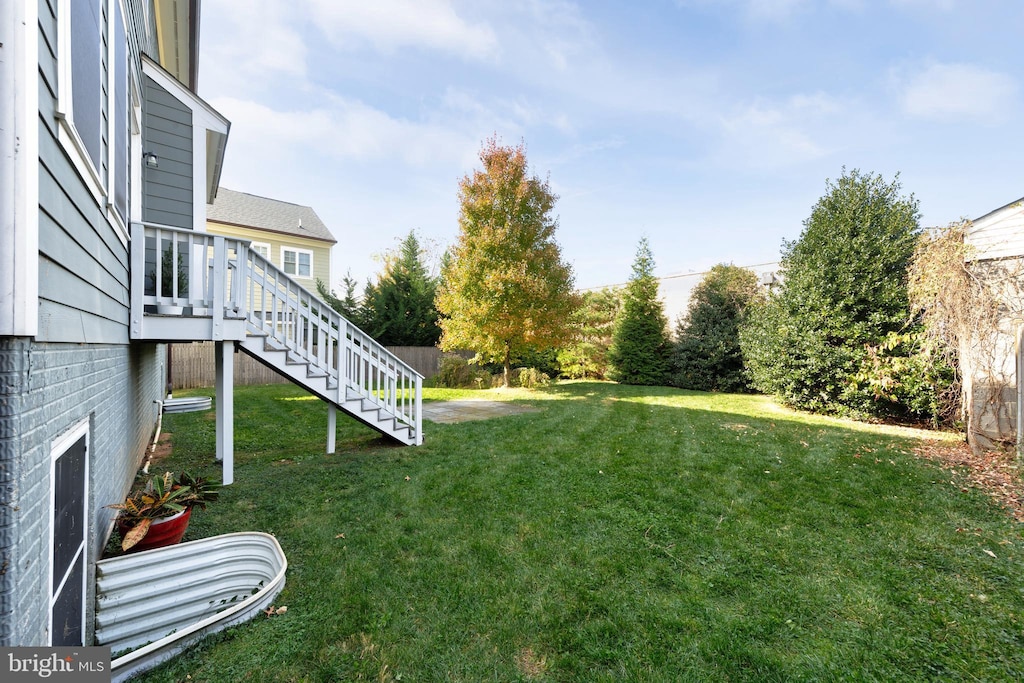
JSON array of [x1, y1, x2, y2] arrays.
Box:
[[206, 187, 338, 244]]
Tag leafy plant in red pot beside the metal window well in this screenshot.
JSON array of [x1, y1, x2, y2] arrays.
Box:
[[106, 472, 220, 551]]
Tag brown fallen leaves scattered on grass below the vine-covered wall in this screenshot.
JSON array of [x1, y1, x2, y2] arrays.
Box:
[[914, 441, 1024, 522]]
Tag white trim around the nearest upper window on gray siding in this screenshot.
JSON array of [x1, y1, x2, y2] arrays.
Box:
[[56, 0, 131, 245]]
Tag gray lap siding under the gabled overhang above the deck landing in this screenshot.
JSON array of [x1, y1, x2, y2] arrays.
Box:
[[142, 76, 194, 229]]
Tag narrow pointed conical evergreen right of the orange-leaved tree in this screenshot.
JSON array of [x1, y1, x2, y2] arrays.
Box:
[[608, 238, 672, 385]]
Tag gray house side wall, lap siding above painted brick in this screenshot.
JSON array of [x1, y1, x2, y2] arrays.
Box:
[[0, 0, 166, 646]]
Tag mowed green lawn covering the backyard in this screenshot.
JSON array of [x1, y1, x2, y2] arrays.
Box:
[[136, 382, 1024, 682]]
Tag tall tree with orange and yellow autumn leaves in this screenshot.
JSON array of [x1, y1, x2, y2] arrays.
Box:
[[436, 136, 580, 386]]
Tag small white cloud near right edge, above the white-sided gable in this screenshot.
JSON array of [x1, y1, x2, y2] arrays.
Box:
[[894, 63, 1019, 124]]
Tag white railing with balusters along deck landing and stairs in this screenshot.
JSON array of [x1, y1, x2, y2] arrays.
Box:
[[132, 223, 423, 443]]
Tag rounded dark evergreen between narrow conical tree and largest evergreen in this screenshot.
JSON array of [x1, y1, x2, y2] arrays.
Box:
[[673, 263, 758, 391]]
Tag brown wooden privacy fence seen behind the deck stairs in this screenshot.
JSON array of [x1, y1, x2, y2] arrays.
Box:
[[170, 342, 442, 389]]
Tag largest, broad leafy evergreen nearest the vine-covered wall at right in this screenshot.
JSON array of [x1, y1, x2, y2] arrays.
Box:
[[740, 170, 920, 413]]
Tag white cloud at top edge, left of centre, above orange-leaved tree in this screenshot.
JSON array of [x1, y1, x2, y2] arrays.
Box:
[[308, 0, 498, 59]]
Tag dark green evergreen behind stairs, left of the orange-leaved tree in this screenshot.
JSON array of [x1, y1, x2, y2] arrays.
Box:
[[362, 230, 440, 346]]
